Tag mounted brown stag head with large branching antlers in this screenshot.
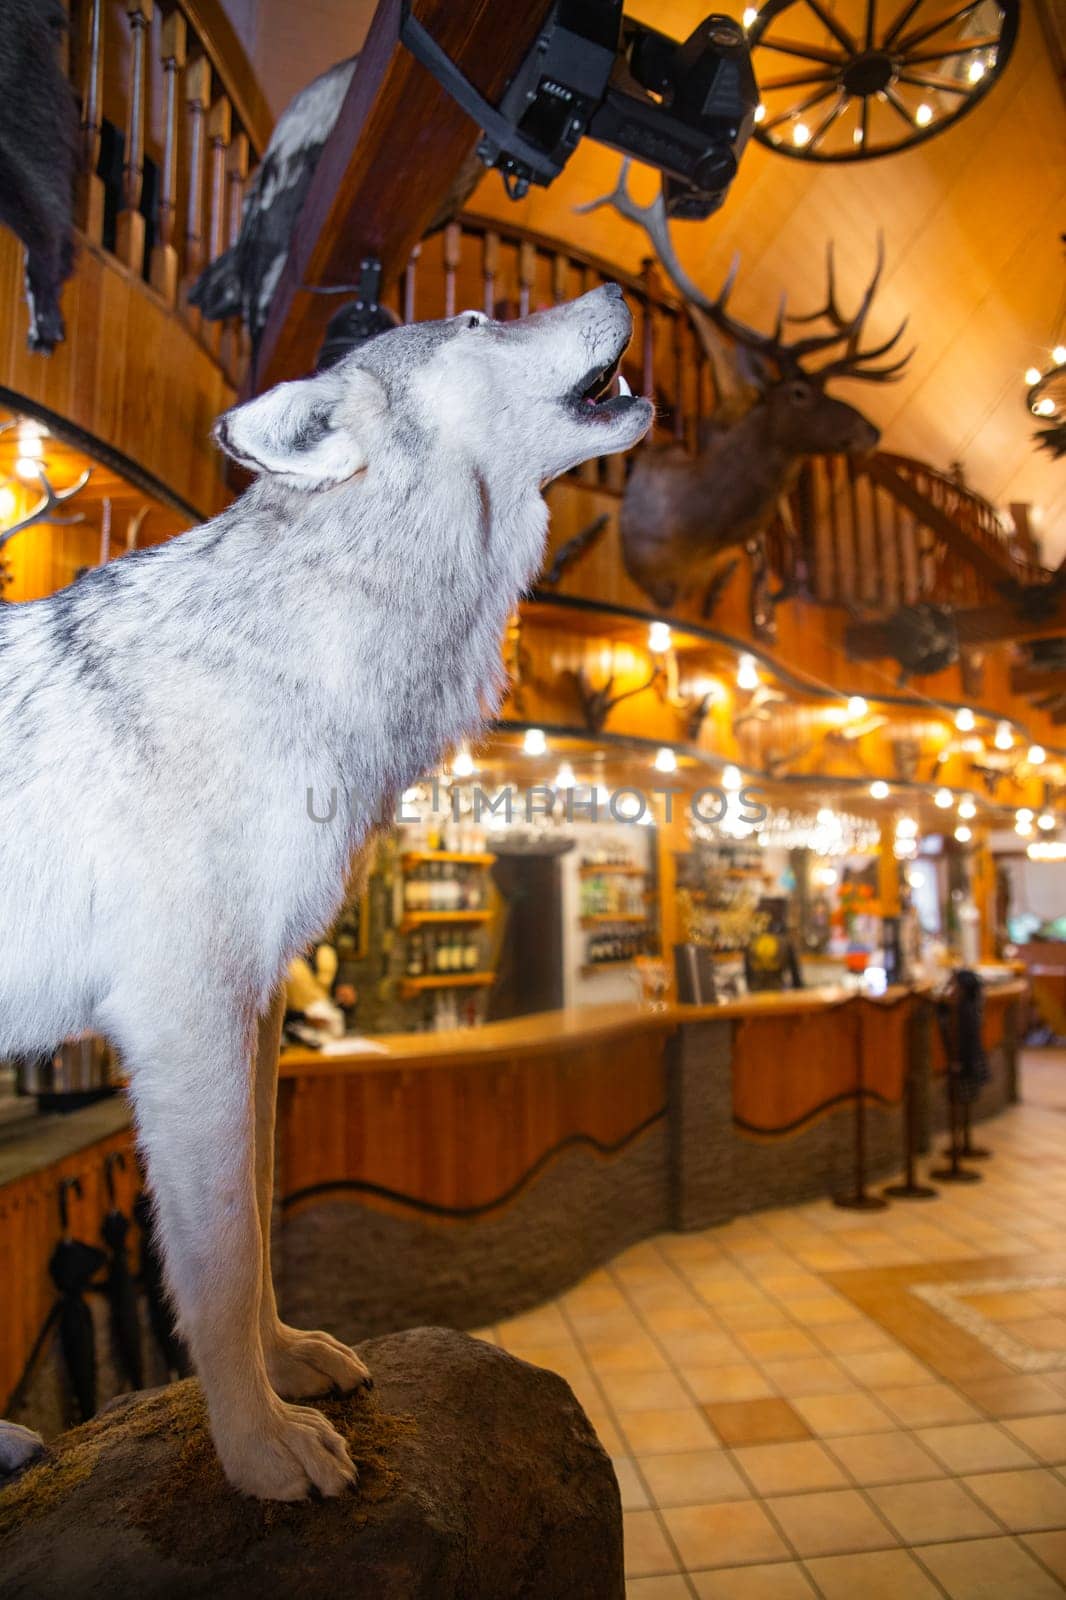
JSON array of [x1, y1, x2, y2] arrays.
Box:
[[554, 162, 911, 616]]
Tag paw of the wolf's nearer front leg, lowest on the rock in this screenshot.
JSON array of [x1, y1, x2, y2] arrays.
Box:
[[216, 1400, 355, 1501]]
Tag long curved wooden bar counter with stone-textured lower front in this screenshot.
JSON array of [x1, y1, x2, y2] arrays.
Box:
[[0, 981, 1028, 1414]]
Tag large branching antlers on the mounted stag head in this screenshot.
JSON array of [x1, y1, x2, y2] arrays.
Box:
[[578, 160, 914, 382]]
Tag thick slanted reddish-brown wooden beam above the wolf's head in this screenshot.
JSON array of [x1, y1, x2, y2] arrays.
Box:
[[254, 0, 551, 390]]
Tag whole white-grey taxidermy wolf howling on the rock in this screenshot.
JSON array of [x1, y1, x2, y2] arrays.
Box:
[[0, 285, 651, 1499]]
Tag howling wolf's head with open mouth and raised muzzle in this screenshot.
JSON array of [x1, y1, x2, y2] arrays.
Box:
[[214, 283, 651, 493]]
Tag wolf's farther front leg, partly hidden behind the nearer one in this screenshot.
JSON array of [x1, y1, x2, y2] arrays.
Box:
[[249, 990, 373, 1400]]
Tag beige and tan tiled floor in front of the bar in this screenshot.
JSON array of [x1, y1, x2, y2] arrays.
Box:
[[470, 1056, 1066, 1600]]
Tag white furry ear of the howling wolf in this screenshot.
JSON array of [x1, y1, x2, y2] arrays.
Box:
[[211, 366, 386, 490]]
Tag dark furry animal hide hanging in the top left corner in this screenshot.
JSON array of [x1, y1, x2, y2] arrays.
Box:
[[0, 0, 77, 354]]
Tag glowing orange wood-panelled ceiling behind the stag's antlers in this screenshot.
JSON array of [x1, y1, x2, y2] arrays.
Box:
[[471, 0, 1066, 562]]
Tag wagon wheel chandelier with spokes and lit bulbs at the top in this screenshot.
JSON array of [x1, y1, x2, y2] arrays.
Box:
[[744, 0, 1018, 162]]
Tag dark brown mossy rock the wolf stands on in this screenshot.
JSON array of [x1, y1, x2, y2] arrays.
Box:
[[0, 1328, 624, 1600]]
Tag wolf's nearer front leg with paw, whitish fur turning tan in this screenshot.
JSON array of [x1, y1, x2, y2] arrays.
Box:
[[125, 1008, 355, 1499]]
